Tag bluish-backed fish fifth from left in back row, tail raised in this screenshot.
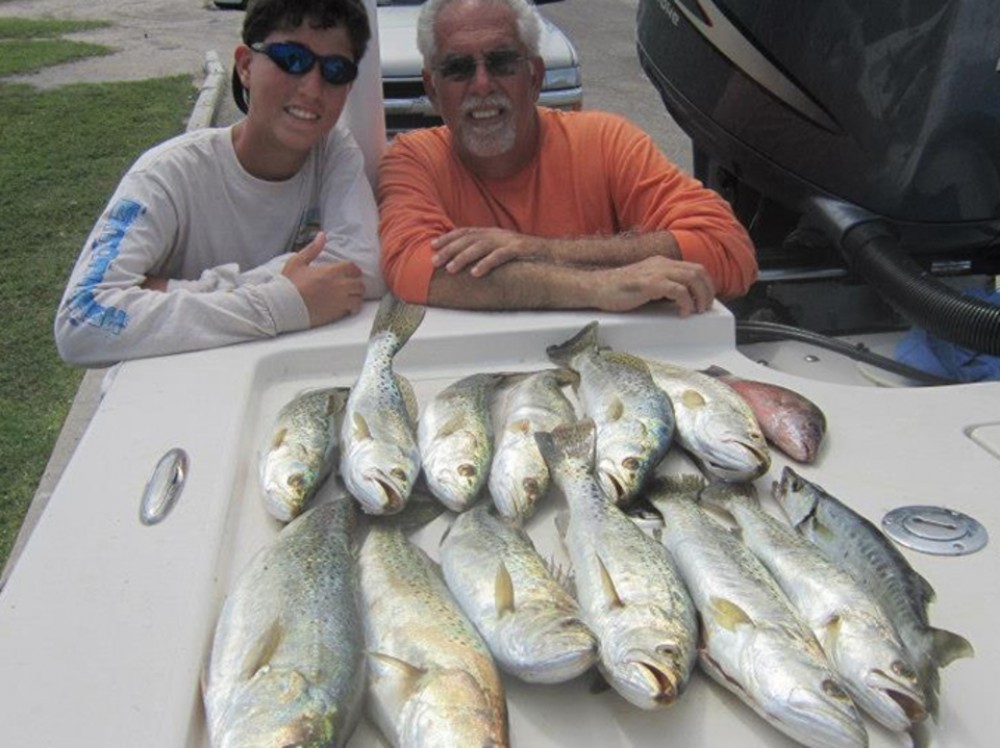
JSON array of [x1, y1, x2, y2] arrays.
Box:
[[547, 322, 674, 506]]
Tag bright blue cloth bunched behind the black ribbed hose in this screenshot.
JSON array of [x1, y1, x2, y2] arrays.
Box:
[[896, 289, 1000, 382]]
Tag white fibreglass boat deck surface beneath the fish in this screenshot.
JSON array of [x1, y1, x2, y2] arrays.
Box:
[[0, 305, 1000, 748]]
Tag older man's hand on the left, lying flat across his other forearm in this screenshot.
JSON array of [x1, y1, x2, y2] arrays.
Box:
[[431, 228, 545, 278]]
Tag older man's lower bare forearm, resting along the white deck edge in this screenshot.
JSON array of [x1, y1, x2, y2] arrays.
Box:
[[428, 262, 594, 310]]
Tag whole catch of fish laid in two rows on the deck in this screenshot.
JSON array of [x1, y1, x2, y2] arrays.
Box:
[[203, 295, 972, 748]]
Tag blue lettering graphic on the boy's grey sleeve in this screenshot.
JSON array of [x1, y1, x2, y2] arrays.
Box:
[[66, 200, 146, 335]]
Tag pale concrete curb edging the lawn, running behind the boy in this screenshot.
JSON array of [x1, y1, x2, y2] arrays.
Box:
[[0, 50, 229, 590]]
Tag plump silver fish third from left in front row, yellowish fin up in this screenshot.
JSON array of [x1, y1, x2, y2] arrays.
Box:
[[441, 503, 597, 683]]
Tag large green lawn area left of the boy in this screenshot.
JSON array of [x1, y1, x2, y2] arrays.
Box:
[[0, 19, 196, 566]]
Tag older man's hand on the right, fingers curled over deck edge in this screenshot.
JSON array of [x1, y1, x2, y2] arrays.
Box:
[[593, 257, 715, 317]]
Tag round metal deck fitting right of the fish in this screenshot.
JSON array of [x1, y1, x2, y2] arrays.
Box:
[[882, 506, 989, 556]]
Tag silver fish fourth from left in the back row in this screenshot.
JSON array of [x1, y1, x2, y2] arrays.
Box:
[[489, 369, 578, 521]]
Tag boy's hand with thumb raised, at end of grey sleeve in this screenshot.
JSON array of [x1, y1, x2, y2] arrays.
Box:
[[281, 231, 365, 327]]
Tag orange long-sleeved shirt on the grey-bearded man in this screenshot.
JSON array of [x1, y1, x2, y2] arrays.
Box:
[[378, 108, 757, 304]]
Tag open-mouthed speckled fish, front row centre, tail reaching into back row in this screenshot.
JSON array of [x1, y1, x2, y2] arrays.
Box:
[[535, 419, 698, 709]]
